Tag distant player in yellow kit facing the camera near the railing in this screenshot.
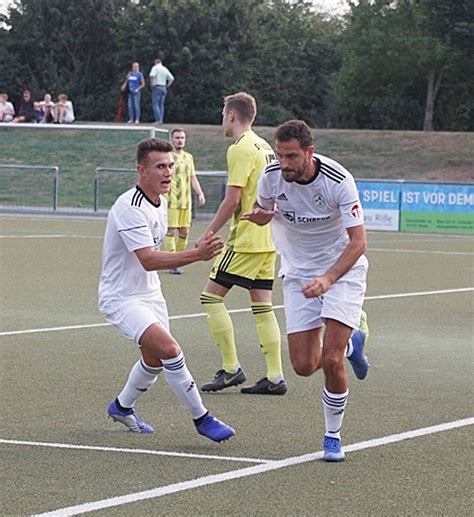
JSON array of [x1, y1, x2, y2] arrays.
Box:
[[165, 127, 206, 275]]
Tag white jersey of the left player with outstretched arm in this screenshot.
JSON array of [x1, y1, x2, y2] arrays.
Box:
[[99, 187, 168, 312]]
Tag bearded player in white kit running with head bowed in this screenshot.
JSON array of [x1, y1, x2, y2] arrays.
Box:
[[243, 120, 369, 461]]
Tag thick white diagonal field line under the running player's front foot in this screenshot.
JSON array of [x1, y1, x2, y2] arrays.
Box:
[[35, 418, 474, 517]]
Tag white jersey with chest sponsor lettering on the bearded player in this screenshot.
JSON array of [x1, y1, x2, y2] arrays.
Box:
[[257, 154, 367, 277]]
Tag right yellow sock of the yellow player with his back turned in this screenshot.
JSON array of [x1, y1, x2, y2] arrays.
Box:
[[251, 302, 283, 382]]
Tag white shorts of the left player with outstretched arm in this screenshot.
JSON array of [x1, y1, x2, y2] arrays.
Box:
[[103, 299, 170, 345]]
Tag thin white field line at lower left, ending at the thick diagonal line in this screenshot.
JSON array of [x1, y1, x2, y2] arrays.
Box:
[[0, 438, 266, 463]]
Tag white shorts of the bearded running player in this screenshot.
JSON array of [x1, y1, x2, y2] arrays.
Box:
[[283, 264, 367, 334]]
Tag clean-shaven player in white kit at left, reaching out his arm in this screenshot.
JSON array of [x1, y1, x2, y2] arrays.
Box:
[[99, 138, 235, 442]]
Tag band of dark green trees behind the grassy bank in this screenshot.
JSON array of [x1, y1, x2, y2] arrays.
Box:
[[0, 0, 474, 130]]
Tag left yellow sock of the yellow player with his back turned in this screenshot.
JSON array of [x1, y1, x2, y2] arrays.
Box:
[[200, 291, 239, 373]]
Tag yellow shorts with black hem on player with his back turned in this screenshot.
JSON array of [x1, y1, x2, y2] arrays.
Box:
[[209, 248, 276, 291]]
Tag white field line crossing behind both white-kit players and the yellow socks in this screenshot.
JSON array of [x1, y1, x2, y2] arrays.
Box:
[[0, 287, 474, 336]]
